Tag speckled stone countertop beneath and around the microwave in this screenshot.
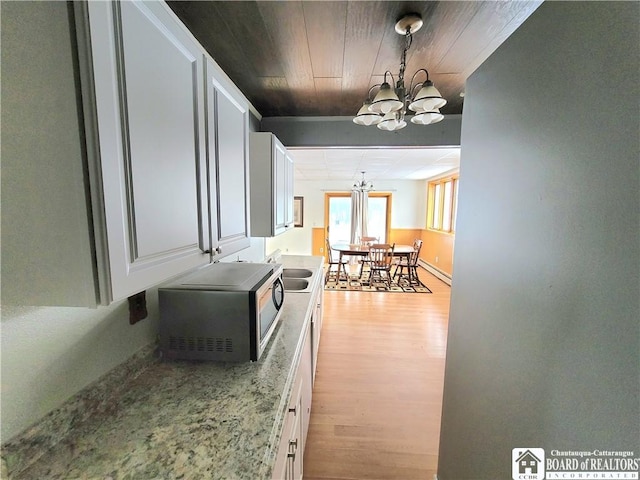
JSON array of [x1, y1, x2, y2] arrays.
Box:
[[3, 256, 322, 480]]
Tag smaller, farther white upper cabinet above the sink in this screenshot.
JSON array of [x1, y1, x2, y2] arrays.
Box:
[[249, 132, 293, 237]]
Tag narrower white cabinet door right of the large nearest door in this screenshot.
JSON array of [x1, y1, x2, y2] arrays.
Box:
[[206, 60, 251, 257]]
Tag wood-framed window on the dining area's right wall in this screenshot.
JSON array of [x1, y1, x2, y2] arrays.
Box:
[[427, 176, 458, 233]]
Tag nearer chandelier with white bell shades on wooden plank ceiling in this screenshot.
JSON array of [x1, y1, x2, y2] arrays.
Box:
[[353, 13, 447, 131]]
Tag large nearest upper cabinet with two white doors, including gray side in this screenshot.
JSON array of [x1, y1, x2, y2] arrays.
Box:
[[2, 1, 258, 307]]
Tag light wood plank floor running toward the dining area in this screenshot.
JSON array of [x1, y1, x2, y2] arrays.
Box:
[[303, 269, 450, 480]]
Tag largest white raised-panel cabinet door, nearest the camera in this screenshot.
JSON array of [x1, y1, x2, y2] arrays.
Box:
[[88, 2, 209, 300]]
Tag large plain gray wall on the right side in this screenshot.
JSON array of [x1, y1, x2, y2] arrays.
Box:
[[438, 2, 640, 480]]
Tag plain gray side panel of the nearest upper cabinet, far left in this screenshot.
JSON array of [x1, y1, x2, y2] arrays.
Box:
[[1, 2, 96, 306]]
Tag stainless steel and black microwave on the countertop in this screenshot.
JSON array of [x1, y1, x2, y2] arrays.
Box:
[[158, 262, 284, 361]]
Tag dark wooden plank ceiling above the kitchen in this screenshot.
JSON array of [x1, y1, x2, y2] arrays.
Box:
[[168, 0, 541, 117]]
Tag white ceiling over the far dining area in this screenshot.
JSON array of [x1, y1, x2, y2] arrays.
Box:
[[289, 148, 460, 183]]
